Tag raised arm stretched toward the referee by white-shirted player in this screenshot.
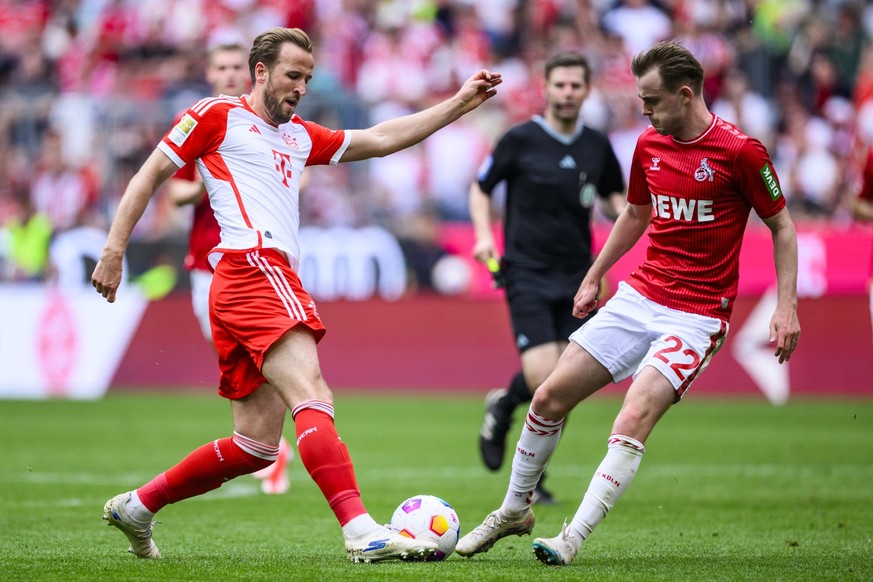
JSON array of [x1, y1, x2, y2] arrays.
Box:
[[340, 69, 503, 162]]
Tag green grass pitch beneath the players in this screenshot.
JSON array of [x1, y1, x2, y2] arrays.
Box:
[[0, 391, 873, 581]]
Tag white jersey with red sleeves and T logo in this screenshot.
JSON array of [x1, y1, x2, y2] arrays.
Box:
[[158, 95, 351, 269]]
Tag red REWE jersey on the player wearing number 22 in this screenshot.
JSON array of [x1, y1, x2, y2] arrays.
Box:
[[628, 115, 785, 321]]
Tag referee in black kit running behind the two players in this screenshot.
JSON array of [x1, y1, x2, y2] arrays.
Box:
[[470, 53, 625, 504]]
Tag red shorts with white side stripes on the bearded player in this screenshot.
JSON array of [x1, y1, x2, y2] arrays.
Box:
[[209, 249, 325, 399]]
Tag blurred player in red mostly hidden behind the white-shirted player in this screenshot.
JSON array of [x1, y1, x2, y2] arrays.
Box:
[[167, 44, 293, 494]]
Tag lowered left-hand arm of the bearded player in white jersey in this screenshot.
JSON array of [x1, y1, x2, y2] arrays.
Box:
[[91, 149, 178, 303]]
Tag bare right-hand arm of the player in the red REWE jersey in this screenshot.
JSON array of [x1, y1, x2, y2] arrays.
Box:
[[764, 208, 800, 364]]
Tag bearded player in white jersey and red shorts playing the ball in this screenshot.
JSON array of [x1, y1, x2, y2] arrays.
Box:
[[92, 28, 501, 562]]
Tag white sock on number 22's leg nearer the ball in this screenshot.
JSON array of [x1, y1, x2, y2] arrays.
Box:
[[500, 409, 564, 516]]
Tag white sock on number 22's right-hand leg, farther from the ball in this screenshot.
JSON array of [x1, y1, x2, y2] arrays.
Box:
[[570, 434, 646, 540]]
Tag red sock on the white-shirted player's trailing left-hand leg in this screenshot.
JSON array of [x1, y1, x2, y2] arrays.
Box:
[[136, 435, 278, 513]]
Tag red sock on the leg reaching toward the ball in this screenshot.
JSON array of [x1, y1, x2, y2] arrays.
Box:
[[292, 400, 367, 526]]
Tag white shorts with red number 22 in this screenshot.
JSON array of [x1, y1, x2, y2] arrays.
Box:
[[570, 282, 728, 398]]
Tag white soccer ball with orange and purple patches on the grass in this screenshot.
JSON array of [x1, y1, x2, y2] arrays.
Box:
[[391, 495, 461, 560]]
